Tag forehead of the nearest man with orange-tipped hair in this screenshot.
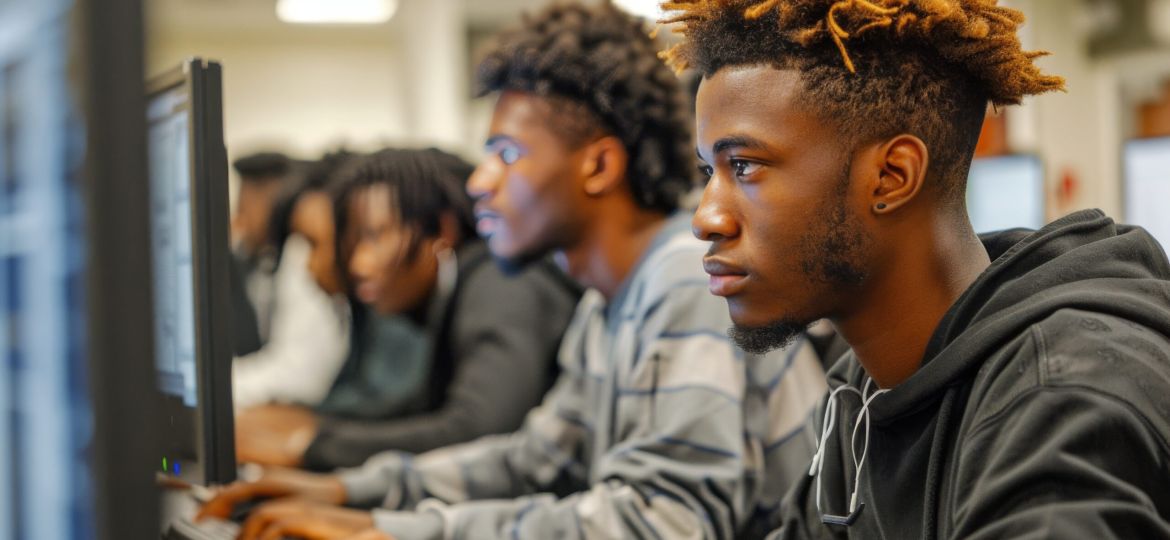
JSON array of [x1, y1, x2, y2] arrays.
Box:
[[695, 65, 832, 157]]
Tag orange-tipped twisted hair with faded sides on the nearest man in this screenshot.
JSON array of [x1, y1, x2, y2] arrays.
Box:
[[662, 0, 1065, 200]]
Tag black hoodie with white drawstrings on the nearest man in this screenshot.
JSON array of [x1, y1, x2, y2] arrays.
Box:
[[771, 210, 1170, 539]]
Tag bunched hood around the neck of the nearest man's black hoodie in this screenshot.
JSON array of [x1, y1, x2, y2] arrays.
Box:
[[865, 210, 1170, 423]]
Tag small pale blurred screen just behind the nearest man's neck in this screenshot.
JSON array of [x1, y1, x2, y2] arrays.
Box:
[[966, 154, 1045, 233]]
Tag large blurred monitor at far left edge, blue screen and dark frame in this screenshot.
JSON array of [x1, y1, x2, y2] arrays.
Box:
[[0, 0, 158, 540]]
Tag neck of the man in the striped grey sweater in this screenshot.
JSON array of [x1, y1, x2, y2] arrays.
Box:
[[562, 198, 666, 300]]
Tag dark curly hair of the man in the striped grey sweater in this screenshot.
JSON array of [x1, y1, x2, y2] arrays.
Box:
[[476, 1, 695, 213]]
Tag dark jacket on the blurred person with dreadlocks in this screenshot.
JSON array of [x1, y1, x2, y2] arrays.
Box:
[[304, 241, 580, 470]]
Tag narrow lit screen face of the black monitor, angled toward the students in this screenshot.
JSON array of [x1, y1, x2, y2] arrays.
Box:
[[147, 86, 199, 408]]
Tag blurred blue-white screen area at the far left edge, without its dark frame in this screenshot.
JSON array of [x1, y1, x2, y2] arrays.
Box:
[[0, 0, 94, 540]]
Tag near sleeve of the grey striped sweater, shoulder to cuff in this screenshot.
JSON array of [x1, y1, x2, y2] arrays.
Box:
[[376, 267, 761, 540]]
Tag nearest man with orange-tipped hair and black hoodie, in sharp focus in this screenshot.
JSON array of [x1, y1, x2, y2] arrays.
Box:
[[665, 0, 1170, 539]]
